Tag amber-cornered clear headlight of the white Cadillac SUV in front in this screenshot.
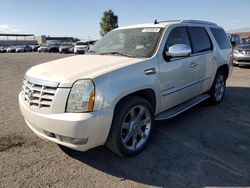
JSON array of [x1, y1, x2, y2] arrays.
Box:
[[66, 79, 95, 112]]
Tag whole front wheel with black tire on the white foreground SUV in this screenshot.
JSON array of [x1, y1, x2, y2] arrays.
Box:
[[105, 96, 154, 156]]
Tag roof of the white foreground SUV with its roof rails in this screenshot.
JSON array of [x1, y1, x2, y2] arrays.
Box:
[[116, 20, 217, 30]]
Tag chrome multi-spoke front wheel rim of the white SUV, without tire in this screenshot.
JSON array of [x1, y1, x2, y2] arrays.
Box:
[[121, 105, 152, 151]]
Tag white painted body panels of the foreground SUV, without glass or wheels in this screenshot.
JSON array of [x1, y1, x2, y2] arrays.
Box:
[[19, 22, 231, 151]]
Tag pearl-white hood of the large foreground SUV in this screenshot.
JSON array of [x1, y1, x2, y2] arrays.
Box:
[[26, 55, 142, 87]]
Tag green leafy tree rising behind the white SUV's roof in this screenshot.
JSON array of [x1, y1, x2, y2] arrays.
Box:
[[100, 10, 118, 36]]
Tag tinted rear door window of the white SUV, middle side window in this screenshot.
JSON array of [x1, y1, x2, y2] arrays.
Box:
[[188, 27, 213, 53]]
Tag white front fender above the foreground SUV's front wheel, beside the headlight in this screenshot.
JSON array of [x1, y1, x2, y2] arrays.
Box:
[[94, 58, 160, 113]]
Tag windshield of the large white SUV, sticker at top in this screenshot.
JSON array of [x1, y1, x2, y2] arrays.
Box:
[[91, 28, 163, 58]]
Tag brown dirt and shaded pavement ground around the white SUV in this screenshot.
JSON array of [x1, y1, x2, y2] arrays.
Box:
[[0, 53, 250, 187]]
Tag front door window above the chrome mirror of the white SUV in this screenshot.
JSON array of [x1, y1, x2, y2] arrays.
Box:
[[165, 27, 191, 50]]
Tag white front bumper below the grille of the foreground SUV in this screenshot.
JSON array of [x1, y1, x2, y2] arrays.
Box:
[[19, 93, 113, 151]]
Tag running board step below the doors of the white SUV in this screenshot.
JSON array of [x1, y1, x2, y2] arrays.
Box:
[[155, 93, 210, 121]]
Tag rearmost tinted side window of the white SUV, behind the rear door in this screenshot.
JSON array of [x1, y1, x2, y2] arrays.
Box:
[[210, 28, 232, 49]]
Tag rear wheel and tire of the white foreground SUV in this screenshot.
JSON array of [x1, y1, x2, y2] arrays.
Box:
[[209, 70, 226, 105]]
